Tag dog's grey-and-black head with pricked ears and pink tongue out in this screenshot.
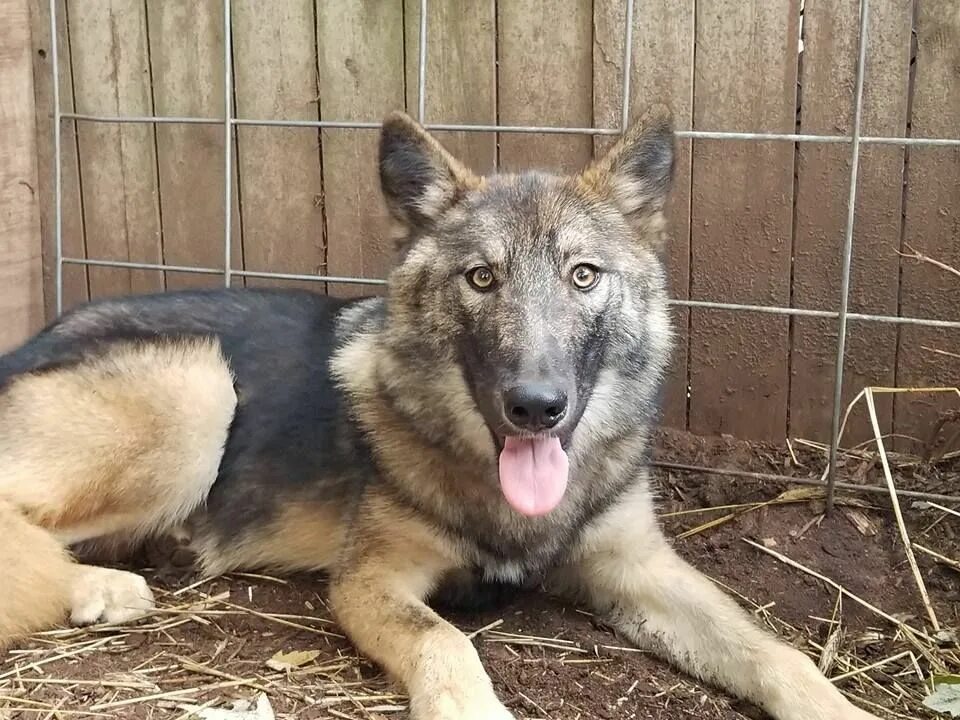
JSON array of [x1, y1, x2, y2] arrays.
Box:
[[380, 112, 673, 515]]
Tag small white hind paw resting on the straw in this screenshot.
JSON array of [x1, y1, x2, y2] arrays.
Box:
[[70, 566, 155, 625]]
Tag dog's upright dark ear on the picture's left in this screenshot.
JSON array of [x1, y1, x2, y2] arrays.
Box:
[[380, 112, 480, 229]]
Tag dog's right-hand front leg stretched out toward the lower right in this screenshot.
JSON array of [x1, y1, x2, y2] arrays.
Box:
[[551, 490, 876, 720]]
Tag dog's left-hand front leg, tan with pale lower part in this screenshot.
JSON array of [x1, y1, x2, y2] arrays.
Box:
[[330, 510, 513, 720]]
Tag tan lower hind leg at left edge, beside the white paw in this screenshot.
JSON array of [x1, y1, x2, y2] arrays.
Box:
[[0, 500, 75, 649]]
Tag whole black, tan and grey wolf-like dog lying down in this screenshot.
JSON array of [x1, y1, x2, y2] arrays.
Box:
[[0, 108, 873, 720]]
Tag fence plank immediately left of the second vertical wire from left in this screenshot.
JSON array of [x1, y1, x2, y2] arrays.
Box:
[[147, 0, 243, 289]]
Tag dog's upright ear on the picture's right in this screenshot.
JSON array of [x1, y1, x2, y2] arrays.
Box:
[[580, 106, 674, 222]]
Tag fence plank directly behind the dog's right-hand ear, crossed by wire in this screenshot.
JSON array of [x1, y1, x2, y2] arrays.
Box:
[[593, 0, 695, 429]]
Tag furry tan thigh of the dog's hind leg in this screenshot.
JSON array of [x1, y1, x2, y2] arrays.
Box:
[[0, 339, 236, 545]]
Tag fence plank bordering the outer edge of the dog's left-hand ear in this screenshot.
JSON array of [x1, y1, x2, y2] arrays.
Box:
[[317, 0, 404, 296]]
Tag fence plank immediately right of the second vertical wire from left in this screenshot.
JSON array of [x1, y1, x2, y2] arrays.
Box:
[[233, 0, 326, 292]]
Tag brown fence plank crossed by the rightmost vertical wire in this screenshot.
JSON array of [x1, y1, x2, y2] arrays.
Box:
[[790, 0, 913, 443]]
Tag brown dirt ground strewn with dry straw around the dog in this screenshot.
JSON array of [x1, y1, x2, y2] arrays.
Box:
[[0, 433, 960, 720]]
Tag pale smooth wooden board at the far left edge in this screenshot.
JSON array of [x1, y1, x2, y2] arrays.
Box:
[[0, 0, 43, 352]]
